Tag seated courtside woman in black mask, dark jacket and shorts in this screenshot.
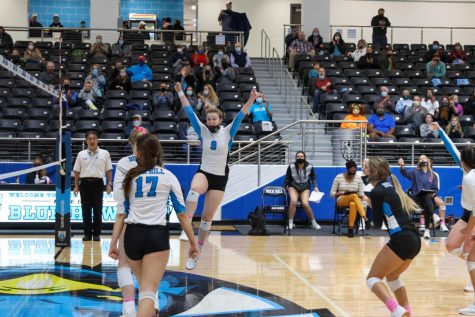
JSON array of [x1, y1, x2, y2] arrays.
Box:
[[284, 151, 322, 230]]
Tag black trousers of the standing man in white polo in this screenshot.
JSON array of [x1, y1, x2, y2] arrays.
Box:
[[79, 178, 104, 236]]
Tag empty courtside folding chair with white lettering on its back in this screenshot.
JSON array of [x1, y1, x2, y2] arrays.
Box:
[[262, 186, 289, 234]]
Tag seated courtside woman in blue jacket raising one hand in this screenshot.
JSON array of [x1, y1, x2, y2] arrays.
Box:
[[398, 155, 439, 239]]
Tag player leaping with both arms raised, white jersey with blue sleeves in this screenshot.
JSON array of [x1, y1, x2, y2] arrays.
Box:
[[175, 83, 257, 270]]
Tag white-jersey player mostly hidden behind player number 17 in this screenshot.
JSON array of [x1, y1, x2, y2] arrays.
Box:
[[114, 127, 148, 317]]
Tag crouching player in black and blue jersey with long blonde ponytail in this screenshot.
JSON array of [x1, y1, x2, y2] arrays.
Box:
[[366, 157, 421, 317]]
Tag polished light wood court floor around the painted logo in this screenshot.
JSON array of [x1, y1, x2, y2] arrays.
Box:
[[0, 232, 474, 317]]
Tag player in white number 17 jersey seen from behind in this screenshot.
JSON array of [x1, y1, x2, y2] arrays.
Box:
[[109, 134, 199, 317]]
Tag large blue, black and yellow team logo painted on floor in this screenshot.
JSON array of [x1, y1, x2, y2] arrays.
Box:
[[0, 266, 334, 317]]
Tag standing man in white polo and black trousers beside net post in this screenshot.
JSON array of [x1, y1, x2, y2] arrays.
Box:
[[73, 130, 112, 241]]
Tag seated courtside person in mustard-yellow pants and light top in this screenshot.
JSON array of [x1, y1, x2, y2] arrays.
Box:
[[330, 160, 370, 238]]
